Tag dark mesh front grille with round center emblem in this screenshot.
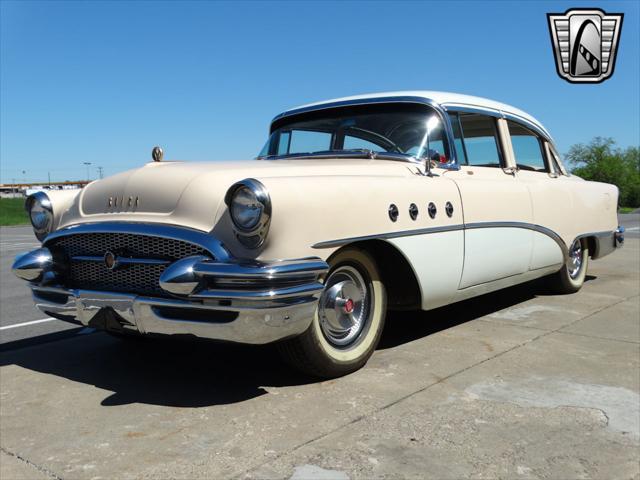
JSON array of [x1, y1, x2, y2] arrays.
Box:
[[50, 233, 210, 296]]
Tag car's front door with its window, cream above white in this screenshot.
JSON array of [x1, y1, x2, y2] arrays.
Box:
[[445, 112, 533, 289]]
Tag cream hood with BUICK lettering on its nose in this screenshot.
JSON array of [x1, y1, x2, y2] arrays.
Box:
[[59, 159, 417, 231]]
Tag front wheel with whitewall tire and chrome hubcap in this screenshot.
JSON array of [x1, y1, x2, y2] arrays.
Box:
[[278, 248, 387, 378]]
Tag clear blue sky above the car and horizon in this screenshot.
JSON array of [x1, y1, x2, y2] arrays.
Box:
[[0, 0, 640, 182]]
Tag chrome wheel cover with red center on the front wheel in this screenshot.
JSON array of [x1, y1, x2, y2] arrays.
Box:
[[318, 265, 372, 347]]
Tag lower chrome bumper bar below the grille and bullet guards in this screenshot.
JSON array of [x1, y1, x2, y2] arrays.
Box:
[[32, 286, 317, 344]]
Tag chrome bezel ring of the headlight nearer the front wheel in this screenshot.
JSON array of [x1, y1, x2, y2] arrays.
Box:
[[224, 178, 271, 249]]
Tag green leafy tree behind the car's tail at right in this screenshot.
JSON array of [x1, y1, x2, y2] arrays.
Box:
[[565, 137, 640, 207]]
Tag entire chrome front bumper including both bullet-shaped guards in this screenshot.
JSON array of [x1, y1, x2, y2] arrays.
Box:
[[13, 225, 329, 344]]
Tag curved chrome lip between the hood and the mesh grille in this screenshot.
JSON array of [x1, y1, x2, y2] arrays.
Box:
[[43, 222, 231, 261]]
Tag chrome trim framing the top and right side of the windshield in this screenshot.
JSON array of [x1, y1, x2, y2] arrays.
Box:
[[269, 96, 459, 170]]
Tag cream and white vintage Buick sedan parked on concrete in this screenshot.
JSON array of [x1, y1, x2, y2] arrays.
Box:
[[13, 92, 623, 377]]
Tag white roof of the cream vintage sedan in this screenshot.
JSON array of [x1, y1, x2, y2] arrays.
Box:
[[276, 90, 551, 137]]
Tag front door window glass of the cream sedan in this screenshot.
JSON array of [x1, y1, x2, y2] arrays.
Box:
[[459, 113, 501, 167]]
